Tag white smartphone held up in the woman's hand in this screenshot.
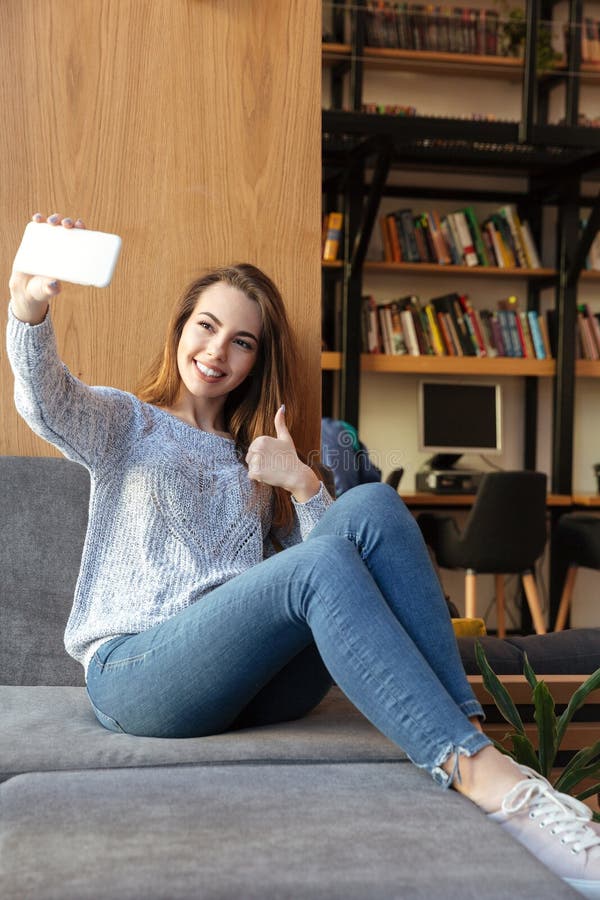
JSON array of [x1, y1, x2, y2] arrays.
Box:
[[13, 222, 121, 287]]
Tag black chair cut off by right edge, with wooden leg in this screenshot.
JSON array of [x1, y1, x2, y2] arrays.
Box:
[[554, 512, 600, 631]]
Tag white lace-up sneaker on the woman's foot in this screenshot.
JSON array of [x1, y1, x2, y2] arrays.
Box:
[[489, 766, 600, 898]]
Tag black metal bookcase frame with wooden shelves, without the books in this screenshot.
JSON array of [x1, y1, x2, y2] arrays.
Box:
[[322, 2, 600, 493]]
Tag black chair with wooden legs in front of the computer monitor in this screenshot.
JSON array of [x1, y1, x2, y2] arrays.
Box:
[[417, 472, 546, 637]]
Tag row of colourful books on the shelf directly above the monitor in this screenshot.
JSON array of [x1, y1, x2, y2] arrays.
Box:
[[361, 293, 552, 359]]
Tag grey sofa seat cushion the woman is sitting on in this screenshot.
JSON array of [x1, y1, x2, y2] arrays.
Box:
[[0, 685, 405, 780]]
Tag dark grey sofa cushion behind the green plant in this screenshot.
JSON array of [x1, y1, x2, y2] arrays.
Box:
[[458, 628, 600, 675]]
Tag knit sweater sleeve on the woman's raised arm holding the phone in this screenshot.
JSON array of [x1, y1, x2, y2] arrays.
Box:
[[6, 306, 135, 469]]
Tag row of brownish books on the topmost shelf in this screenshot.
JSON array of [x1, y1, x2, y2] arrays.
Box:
[[365, 0, 501, 56]]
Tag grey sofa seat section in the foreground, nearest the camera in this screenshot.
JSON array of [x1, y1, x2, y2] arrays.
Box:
[[0, 763, 576, 900]]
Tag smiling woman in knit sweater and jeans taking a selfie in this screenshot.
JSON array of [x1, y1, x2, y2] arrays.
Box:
[[8, 215, 600, 897]]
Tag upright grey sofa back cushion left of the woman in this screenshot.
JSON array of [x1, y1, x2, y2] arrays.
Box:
[[0, 456, 90, 685]]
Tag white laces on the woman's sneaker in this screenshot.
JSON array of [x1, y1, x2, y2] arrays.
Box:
[[502, 771, 600, 853]]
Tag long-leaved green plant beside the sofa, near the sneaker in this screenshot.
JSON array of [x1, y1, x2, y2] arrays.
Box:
[[475, 641, 600, 822]]
